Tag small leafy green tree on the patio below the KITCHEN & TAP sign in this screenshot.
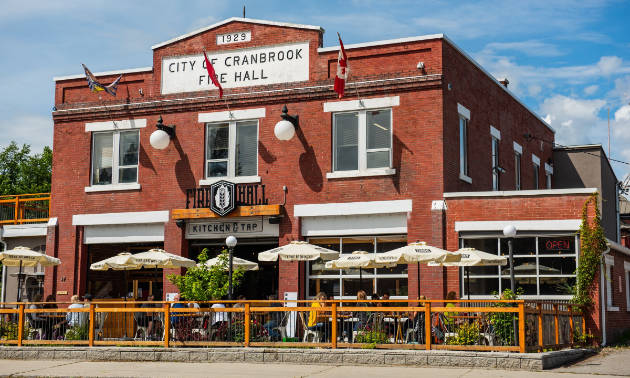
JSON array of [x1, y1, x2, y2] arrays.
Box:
[[167, 248, 244, 301]]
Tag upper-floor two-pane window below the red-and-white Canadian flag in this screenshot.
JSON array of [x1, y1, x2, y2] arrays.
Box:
[[333, 109, 393, 172]]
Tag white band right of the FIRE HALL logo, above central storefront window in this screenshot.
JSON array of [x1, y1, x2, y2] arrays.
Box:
[[293, 200, 411, 217]]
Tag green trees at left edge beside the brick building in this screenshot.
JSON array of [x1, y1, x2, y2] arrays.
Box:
[[0, 142, 52, 195]]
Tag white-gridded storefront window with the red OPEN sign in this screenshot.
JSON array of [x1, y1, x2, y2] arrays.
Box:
[[460, 235, 578, 299]]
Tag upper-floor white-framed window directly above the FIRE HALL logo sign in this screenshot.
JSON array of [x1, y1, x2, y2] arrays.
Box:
[[205, 120, 258, 181]]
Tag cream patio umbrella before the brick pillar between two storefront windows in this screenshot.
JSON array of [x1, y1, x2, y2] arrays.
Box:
[[375, 241, 461, 295]]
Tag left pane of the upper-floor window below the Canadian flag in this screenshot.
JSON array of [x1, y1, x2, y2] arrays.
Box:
[[334, 113, 359, 171]]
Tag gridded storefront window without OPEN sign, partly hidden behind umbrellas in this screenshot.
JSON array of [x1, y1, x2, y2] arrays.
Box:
[[308, 236, 407, 299]]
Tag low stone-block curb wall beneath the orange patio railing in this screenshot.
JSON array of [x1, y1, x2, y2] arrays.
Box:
[[0, 347, 594, 370]]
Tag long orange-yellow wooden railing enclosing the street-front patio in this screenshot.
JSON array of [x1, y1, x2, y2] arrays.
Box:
[[0, 300, 585, 353]]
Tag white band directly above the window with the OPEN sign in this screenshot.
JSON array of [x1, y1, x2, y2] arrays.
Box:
[[455, 219, 582, 235]]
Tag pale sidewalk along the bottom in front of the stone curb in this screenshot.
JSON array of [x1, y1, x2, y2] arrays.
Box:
[[0, 360, 630, 378]]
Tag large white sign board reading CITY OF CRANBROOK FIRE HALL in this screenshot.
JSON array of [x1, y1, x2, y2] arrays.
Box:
[[162, 42, 309, 95]]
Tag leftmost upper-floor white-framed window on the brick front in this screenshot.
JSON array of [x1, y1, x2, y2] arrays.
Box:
[[91, 130, 140, 189]]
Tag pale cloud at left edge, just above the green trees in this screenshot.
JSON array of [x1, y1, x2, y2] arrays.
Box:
[[0, 114, 53, 153]]
